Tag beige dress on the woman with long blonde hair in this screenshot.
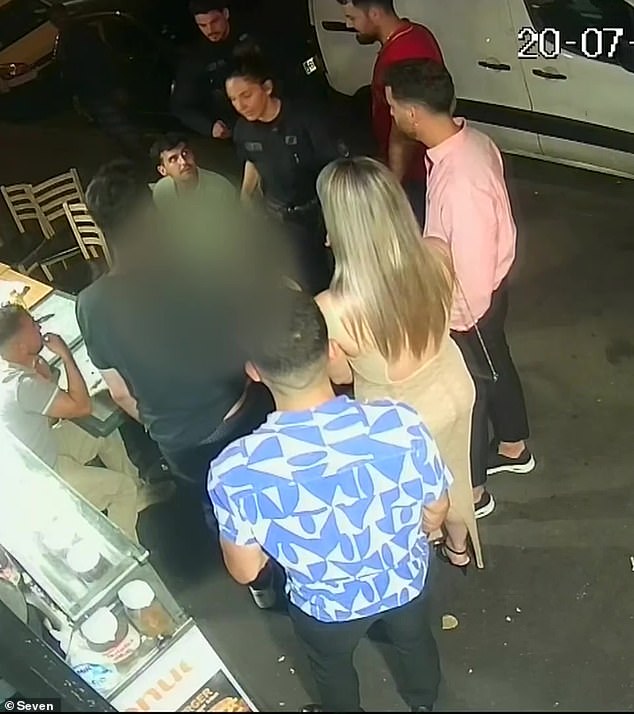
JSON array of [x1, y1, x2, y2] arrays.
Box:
[[324, 309, 484, 568]]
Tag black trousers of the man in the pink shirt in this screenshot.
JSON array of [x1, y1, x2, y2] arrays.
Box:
[[451, 281, 529, 486]]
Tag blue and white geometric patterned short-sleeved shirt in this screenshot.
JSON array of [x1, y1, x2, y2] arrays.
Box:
[[207, 397, 452, 622]]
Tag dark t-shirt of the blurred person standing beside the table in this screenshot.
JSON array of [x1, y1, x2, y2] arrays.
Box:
[[77, 269, 246, 453]]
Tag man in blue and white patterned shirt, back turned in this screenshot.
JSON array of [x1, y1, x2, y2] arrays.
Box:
[[208, 291, 452, 712]]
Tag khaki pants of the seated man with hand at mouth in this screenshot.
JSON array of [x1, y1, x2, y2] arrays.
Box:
[[53, 421, 139, 543]]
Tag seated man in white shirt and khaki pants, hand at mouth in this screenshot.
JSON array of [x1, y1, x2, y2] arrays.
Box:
[[0, 305, 166, 541]]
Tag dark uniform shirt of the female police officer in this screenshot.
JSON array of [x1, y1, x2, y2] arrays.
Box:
[[234, 100, 347, 206]]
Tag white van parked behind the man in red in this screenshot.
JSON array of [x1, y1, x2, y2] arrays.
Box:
[[308, 0, 634, 178]]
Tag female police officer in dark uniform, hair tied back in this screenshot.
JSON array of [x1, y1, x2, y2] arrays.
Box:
[[226, 56, 347, 295]]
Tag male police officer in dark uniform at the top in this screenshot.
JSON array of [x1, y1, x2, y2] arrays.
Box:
[[171, 0, 261, 139]]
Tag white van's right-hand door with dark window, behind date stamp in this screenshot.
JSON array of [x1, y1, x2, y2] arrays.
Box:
[[511, 0, 634, 176]]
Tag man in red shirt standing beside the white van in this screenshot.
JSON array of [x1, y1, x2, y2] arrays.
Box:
[[338, 0, 444, 226]]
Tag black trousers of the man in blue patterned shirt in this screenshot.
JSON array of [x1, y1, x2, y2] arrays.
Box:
[[289, 591, 440, 712]]
